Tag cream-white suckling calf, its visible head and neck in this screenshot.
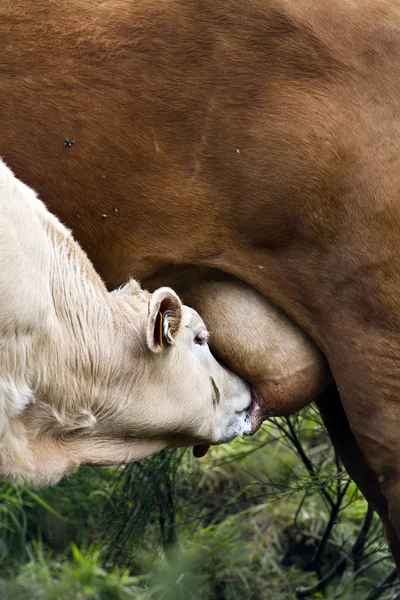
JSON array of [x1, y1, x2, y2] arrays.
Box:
[[0, 161, 258, 484]]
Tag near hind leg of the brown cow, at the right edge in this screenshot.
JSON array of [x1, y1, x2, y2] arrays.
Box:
[[330, 332, 400, 571]]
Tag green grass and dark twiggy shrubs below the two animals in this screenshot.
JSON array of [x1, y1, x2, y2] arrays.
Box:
[[0, 409, 400, 600]]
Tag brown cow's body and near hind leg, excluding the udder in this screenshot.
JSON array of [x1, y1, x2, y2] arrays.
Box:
[[0, 0, 400, 565]]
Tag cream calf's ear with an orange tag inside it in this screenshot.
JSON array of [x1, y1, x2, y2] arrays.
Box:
[[146, 287, 182, 352]]
